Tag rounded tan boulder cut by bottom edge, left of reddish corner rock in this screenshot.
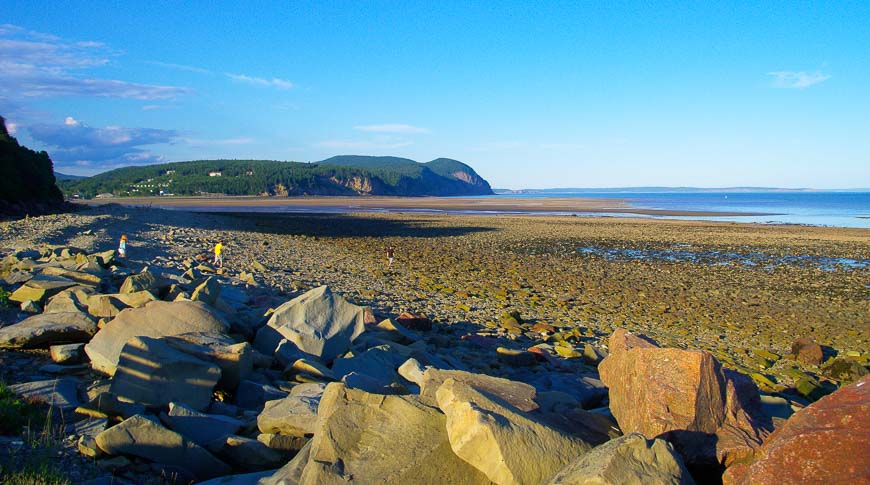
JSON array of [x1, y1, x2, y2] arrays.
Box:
[[546, 433, 695, 485]]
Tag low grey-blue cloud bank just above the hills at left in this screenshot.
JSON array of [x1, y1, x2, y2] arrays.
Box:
[[27, 116, 180, 171]]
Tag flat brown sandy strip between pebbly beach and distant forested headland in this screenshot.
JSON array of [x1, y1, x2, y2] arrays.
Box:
[[72, 196, 776, 217]]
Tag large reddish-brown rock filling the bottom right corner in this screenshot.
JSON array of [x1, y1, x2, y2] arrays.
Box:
[[723, 376, 870, 485]]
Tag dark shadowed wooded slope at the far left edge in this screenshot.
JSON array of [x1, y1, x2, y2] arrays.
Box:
[[0, 116, 63, 214]]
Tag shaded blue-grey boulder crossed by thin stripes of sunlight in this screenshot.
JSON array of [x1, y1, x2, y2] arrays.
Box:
[[110, 337, 221, 410]]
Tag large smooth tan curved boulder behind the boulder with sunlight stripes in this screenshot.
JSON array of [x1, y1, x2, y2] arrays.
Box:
[[85, 301, 229, 375]]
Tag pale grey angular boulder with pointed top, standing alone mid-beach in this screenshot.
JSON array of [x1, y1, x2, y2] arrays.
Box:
[[255, 286, 365, 362]]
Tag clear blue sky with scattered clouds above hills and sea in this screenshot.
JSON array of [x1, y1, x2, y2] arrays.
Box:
[[0, 0, 870, 188]]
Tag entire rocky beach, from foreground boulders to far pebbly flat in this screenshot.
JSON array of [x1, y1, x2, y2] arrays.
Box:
[[0, 204, 870, 483]]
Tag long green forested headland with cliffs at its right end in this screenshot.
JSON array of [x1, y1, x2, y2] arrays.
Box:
[[60, 155, 493, 198]]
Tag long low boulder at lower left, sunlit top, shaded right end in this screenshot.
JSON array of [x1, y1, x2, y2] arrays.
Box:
[[96, 414, 232, 480]]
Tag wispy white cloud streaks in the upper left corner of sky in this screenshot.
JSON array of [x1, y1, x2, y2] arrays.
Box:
[[0, 24, 191, 100]]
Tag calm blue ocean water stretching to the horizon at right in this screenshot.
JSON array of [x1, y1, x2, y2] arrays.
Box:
[[488, 191, 870, 228]]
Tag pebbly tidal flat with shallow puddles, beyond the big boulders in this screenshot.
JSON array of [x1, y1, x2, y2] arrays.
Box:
[[2, 205, 870, 391]]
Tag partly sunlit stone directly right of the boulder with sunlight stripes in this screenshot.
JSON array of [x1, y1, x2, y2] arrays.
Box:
[[163, 332, 254, 390]]
